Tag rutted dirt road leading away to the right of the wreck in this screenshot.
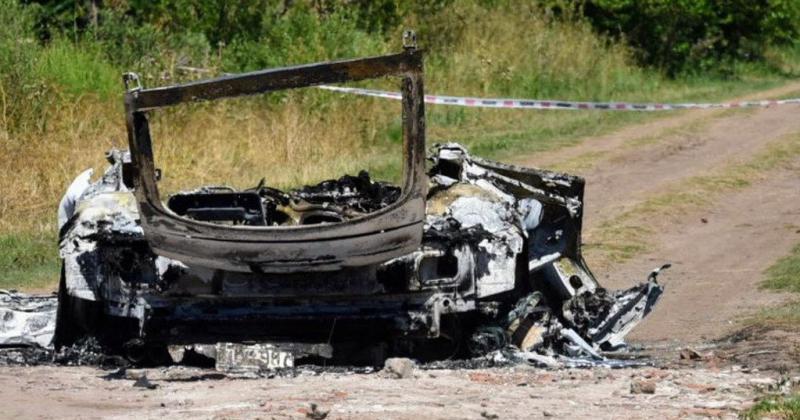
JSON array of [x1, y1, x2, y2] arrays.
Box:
[[518, 83, 800, 342]]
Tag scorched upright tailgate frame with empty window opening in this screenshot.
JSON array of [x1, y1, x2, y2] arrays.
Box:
[[125, 48, 428, 273]]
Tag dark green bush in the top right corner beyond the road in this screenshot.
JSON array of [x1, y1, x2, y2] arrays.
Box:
[[581, 0, 800, 76]]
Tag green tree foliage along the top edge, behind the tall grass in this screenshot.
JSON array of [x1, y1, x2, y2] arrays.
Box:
[[14, 0, 800, 76]]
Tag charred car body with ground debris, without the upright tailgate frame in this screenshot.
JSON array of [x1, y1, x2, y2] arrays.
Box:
[[0, 143, 668, 372]]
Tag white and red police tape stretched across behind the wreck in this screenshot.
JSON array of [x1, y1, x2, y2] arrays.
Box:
[[317, 85, 800, 111]]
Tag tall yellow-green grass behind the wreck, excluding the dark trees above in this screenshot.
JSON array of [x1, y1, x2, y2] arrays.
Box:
[[0, 0, 800, 287]]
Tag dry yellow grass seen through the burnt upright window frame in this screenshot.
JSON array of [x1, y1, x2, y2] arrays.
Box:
[[151, 89, 402, 194]]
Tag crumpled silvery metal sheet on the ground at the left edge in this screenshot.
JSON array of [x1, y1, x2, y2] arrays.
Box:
[[0, 290, 58, 347]]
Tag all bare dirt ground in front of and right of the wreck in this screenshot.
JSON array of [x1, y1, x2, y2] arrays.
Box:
[[0, 83, 800, 419]]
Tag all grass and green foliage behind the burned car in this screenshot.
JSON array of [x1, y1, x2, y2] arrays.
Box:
[[0, 0, 800, 287]]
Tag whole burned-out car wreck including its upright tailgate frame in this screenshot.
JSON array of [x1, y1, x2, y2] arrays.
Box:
[[48, 47, 662, 370]]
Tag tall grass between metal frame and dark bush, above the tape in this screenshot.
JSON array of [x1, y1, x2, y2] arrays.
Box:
[[418, 2, 648, 100]]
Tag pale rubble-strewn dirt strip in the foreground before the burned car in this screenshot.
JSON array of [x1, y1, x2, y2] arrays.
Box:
[[0, 367, 788, 420]]
